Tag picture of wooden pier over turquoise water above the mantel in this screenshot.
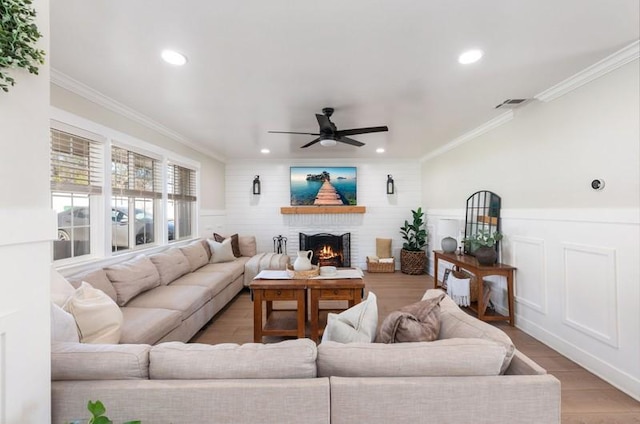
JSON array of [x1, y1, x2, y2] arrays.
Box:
[[290, 166, 358, 206]]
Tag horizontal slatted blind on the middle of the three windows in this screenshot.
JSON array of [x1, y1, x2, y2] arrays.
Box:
[[111, 146, 162, 199]]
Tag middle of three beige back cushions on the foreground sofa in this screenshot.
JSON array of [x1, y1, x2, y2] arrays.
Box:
[[149, 339, 317, 380]]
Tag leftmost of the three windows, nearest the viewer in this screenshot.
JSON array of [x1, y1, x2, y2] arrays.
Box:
[[51, 129, 102, 260]]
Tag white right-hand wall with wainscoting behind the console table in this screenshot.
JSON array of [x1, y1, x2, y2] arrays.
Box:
[[422, 59, 640, 399]]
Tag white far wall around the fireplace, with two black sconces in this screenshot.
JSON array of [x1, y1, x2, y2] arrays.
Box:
[[222, 159, 421, 268]]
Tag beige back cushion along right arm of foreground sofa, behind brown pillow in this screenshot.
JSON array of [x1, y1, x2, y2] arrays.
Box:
[[423, 289, 515, 373]]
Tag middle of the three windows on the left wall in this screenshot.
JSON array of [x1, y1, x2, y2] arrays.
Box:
[[111, 146, 162, 252]]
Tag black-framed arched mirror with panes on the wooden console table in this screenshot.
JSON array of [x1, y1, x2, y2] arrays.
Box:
[[464, 190, 500, 255]]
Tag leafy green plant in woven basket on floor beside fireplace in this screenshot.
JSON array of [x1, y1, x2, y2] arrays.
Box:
[[400, 207, 427, 275]]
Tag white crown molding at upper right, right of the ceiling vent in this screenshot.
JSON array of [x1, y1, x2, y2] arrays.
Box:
[[534, 41, 640, 102]]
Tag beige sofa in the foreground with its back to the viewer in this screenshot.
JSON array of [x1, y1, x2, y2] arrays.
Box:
[[52, 290, 560, 424]]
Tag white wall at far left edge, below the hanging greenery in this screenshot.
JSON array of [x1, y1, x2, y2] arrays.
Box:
[[0, 0, 55, 424]]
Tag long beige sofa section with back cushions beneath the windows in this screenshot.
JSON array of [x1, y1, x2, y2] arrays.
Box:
[[62, 236, 288, 344]]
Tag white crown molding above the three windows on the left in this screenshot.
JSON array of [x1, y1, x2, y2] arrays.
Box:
[[51, 68, 226, 162]]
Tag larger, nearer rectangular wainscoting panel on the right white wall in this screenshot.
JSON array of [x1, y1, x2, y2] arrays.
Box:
[[562, 243, 618, 347]]
